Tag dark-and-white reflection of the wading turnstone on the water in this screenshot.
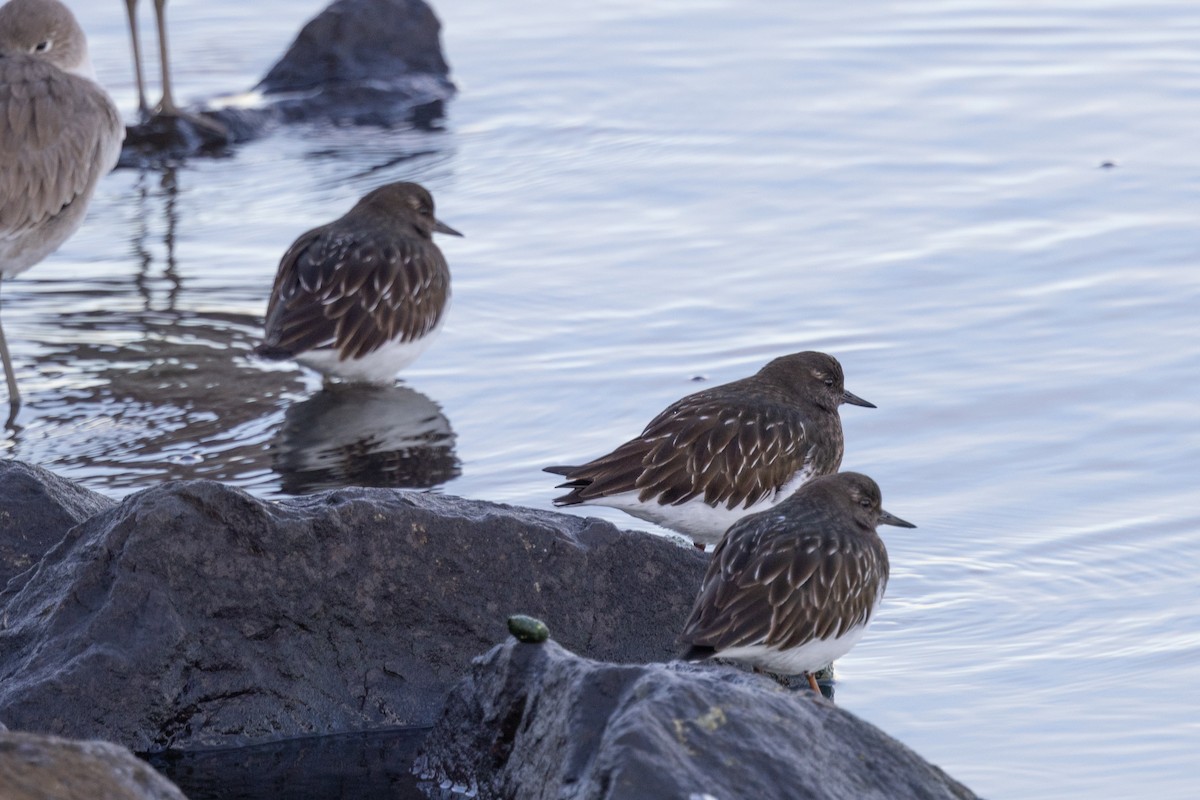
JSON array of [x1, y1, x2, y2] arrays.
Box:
[[271, 384, 461, 494]]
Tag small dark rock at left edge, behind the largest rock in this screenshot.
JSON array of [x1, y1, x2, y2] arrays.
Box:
[[0, 461, 113, 589]]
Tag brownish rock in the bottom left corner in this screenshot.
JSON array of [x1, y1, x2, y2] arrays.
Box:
[[0, 733, 186, 800]]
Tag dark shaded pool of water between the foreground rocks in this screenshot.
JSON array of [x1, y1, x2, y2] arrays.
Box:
[[145, 728, 428, 800]]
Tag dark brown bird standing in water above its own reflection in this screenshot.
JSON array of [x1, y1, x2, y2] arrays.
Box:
[[256, 184, 462, 384]]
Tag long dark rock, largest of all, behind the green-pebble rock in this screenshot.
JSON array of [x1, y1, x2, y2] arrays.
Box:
[[0, 481, 706, 752]]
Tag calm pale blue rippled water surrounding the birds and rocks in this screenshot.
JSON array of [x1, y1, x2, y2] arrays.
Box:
[[2, 0, 1200, 799]]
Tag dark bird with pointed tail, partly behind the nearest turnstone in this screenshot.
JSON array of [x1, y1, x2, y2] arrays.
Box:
[[545, 351, 875, 547]]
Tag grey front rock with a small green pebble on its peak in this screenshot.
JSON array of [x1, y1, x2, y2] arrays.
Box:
[[414, 639, 976, 800]]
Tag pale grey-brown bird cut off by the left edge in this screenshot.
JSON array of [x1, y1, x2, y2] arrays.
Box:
[[0, 0, 125, 423]]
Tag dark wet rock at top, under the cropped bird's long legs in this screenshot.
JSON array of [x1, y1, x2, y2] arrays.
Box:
[[120, 0, 455, 167]]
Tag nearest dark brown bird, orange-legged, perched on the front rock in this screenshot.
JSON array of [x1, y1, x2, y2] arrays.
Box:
[[679, 473, 916, 692]]
